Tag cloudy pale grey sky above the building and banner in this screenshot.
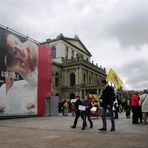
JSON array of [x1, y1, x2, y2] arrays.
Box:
[[0, 0, 148, 90]]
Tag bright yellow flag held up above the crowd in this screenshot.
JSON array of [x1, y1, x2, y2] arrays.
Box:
[[106, 68, 123, 89]]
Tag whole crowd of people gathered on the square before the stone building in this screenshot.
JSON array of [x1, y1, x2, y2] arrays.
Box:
[[59, 80, 148, 131]]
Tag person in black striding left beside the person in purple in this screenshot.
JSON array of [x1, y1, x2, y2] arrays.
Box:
[[71, 96, 85, 130]]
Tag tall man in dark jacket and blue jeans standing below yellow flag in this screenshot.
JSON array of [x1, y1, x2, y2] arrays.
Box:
[[99, 80, 115, 131]]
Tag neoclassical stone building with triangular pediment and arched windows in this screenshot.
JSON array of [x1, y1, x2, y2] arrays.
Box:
[[43, 34, 106, 99]]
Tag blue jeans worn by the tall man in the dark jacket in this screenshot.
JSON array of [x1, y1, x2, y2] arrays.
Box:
[[102, 107, 115, 129]]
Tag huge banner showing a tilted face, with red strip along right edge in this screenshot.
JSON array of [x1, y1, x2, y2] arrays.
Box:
[[0, 27, 51, 116]]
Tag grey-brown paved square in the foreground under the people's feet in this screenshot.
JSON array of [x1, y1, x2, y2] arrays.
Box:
[[0, 113, 148, 148]]
